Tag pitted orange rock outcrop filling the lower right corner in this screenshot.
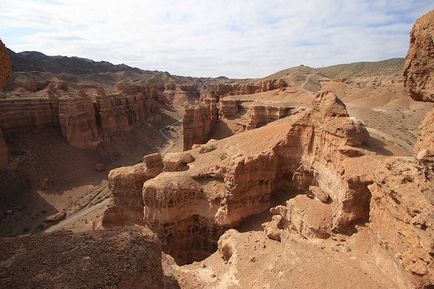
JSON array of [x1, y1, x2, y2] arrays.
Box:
[[369, 158, 434, 288]]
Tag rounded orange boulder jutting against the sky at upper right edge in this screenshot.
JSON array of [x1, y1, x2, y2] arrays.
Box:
[[404, 10, 434, 101]]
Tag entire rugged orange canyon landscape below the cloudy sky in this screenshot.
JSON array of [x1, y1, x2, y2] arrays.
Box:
[[0, 11, 434, 289]]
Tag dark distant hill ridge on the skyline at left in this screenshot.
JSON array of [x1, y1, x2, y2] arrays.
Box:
[[8, 49, 144, 75]]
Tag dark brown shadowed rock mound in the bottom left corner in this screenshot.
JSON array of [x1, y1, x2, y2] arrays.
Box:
[[0, 226, 176, 289]]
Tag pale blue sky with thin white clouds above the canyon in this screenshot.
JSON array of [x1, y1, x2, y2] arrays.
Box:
[[0, 0, 434, 78]]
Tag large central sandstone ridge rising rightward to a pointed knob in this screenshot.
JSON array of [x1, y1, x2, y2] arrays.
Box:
[[104, 93, 370, 263]]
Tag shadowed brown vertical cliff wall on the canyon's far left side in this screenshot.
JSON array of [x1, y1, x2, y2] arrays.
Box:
[[0, 88, 158, 149]]
